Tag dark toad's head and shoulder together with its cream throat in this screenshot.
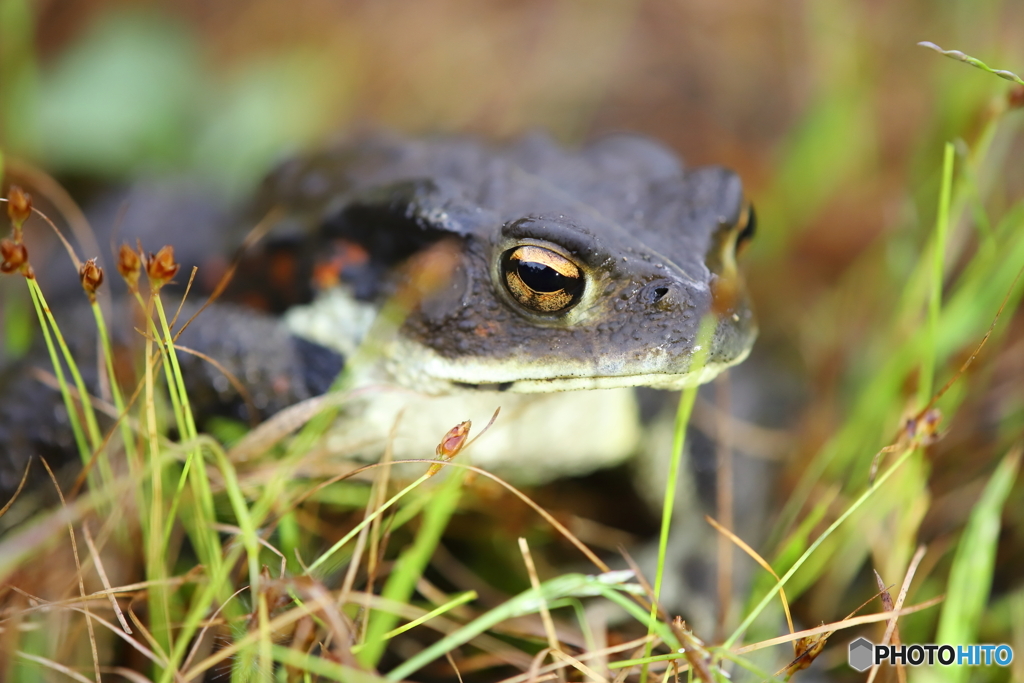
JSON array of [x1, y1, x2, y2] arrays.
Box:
[[0, 135, 756, 489]]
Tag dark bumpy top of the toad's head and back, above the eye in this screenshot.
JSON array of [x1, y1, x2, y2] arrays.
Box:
[[233, 133, 742, 310]]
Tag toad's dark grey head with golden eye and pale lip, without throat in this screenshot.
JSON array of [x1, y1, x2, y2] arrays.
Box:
[[251, 136, 755, 393]]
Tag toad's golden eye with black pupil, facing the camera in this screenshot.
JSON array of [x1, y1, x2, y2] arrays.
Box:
[[502, 245, 584, 313]]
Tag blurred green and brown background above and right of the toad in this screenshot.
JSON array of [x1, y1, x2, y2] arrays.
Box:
[[0, 0, 1024, 679]]
